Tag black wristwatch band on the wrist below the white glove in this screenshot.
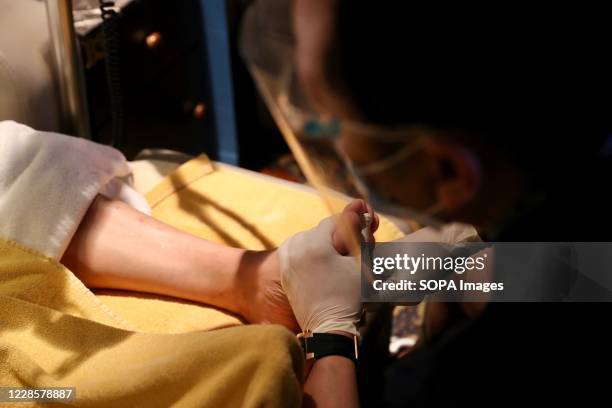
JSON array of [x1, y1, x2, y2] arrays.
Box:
[[297, 331, 359, 363]]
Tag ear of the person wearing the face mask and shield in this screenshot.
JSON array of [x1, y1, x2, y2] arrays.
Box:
[[425, 138, 481, 212]]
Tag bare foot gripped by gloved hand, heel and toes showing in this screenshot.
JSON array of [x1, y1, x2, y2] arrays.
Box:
[[239, 200, 379, 333]]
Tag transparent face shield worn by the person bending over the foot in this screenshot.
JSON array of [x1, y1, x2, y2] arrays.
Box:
[[240, 0, 441, 254]]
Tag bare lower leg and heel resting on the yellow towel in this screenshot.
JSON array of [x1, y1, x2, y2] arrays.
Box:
[[62, 197, 298, 332]]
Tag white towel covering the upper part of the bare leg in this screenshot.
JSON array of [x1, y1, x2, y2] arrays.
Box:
[[0, 121, 150, 260]]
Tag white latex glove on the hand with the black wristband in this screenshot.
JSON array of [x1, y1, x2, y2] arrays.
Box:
[[278, 217, 362, 335]]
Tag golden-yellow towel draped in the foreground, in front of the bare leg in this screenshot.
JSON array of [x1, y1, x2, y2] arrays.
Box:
[[0, 239, 303, 407]]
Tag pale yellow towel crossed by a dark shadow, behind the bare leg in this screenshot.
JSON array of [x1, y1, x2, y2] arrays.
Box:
[[146, 155, 404, 249]]
